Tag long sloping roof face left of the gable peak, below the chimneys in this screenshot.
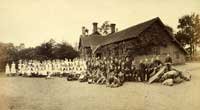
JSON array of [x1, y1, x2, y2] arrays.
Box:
[[80, 18, 158, 47]]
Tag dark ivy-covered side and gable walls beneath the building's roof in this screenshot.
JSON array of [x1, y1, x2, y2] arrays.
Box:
[[96, 20, 185, 64]]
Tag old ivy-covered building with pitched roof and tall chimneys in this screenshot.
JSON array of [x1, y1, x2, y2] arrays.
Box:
[[79, 17, 187, 63]]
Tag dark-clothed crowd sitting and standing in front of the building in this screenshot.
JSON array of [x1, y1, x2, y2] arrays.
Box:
[[79, 55, 172, 87]]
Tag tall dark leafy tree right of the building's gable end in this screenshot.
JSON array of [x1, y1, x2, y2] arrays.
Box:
[[175, 13, 200, 57]]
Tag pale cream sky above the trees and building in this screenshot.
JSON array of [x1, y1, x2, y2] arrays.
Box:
[[0, 0, 200, 47]]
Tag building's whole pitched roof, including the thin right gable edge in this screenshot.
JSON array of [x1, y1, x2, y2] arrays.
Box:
[[80, 17, 187, 54]]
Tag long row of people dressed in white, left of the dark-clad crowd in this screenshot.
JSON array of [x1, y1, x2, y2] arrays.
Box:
[[5, 58, 86, 77]]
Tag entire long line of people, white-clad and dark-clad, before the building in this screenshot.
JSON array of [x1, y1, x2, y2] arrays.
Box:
[[6, 55, 172, 87]]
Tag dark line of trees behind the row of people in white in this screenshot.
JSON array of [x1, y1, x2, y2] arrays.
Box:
[[0, 39, 79, 71]]
